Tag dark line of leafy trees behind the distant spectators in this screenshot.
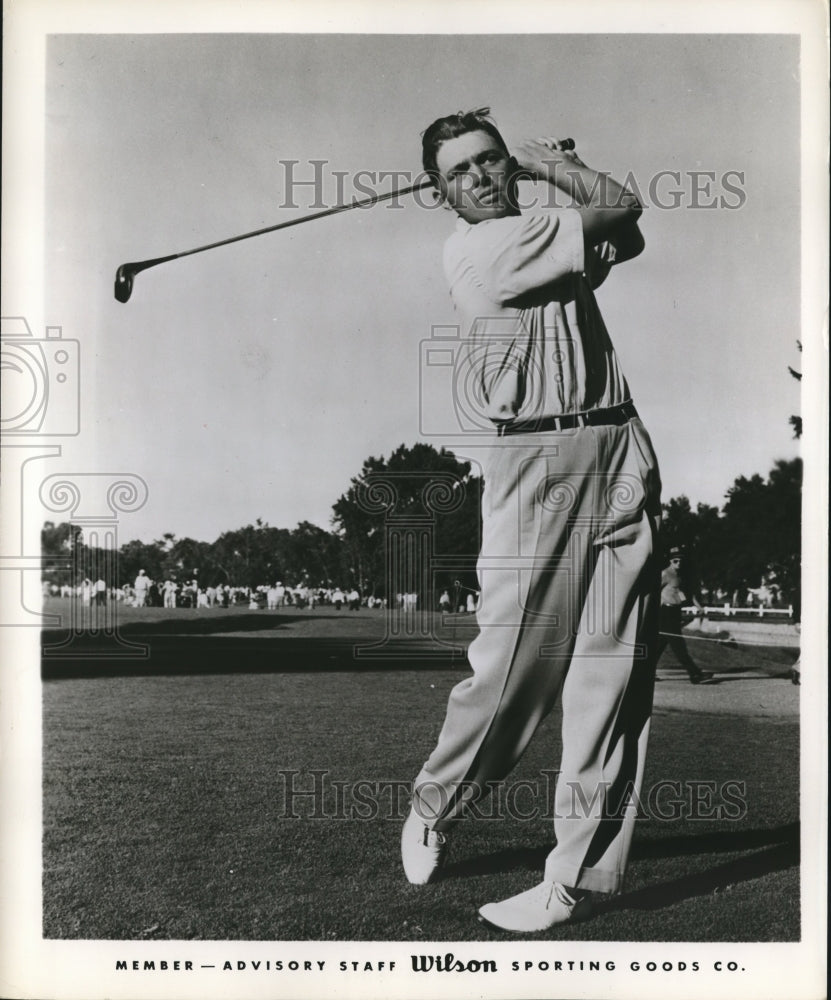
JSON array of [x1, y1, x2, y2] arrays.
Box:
[[41, 444, 802, 606]]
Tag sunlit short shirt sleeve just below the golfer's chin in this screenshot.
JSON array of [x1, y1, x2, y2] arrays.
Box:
[[466, 209, 585, 305]]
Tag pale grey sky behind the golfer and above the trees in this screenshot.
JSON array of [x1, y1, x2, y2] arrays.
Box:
[[17, 23, 802, 541]]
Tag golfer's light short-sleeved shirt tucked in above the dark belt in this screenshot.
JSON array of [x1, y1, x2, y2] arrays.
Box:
[[444, 209, 629, 422]]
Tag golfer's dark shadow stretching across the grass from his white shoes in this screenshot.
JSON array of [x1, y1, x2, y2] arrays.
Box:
[[442, 823, 799, 913]]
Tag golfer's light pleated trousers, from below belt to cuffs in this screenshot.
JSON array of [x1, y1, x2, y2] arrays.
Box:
[[414, 419, 660, 893]]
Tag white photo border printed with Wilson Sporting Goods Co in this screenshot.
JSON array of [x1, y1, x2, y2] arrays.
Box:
[[0, 0, 828, 1000]]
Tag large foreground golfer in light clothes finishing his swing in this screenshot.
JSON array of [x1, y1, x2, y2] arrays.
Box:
[[401, 109, 660, 933]]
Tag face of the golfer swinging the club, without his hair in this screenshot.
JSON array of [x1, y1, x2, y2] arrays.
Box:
[[436, 132, 518, 225]]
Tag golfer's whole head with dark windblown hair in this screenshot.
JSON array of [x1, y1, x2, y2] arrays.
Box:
[[421, 108, 519, 224]]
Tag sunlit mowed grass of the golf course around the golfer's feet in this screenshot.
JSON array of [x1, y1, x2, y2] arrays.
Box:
[[43, 609, 800, 941]]
